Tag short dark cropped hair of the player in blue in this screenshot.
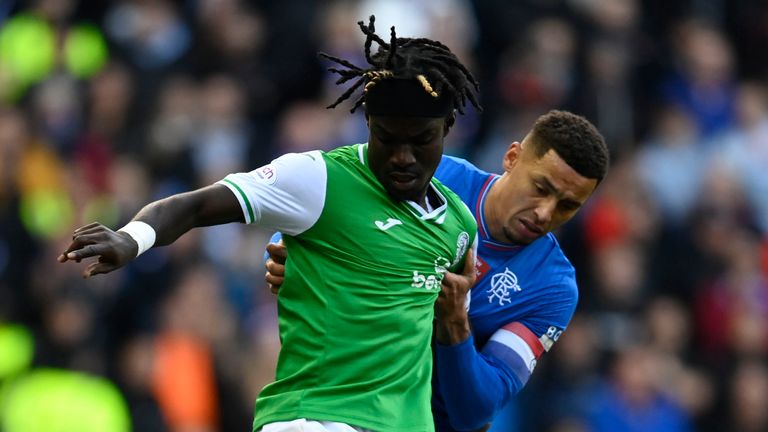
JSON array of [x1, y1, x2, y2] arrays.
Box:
[[531, 110, 610, 183]]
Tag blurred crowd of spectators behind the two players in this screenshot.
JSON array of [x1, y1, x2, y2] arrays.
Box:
[[0, 0, 768, 432]]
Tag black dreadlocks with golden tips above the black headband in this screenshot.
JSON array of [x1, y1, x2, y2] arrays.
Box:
[[320, 15, 483, 114]]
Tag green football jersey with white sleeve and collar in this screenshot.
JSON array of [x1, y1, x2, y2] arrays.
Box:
[[220, 144, 477, 432]]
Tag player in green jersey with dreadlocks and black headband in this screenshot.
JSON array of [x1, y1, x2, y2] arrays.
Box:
[[59, 17, 479, 432]]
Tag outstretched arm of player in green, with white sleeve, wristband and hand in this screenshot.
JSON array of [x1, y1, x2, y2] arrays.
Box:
[[59, 152, 327, 277]]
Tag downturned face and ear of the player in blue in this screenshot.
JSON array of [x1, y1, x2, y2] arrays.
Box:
[[485, 135, 597, 244]]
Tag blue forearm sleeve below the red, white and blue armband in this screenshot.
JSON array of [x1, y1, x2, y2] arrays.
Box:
[[435, 336, 523, 430]]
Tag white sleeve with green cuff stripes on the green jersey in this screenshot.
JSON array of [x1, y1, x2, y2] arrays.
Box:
[[218, 151, 328, 235]]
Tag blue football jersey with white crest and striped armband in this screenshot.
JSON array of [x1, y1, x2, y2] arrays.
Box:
[[433, 156, 578, 431]]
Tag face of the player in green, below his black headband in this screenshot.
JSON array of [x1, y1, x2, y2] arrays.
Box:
[[368, 116, 449, 202]]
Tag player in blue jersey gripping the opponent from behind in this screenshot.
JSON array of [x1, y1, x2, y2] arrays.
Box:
[[267, 111, 609, 431]]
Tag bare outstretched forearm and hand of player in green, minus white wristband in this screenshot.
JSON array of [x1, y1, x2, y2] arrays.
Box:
[[58, 185, 244, 277]]
